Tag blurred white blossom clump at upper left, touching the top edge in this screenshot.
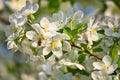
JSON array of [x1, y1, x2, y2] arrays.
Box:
[[9, 0, 38, 28]]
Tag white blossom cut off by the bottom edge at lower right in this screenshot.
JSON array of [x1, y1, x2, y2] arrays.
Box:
[[91, 71, 112, 80]]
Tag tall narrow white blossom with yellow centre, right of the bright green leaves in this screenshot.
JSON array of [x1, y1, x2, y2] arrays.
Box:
[[84, 17, 99, 45]]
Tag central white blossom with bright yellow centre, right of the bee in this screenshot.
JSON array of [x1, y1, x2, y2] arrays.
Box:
[[43, 34, 70, 58]]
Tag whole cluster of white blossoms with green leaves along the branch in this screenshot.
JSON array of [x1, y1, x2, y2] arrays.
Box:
[[5, 0, 120, 80]]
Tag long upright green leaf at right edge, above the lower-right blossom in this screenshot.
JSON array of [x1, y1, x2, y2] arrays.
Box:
[[110, 44, 118, 61]]
